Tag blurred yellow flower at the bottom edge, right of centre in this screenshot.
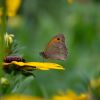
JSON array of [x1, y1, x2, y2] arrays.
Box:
[[52, 91, 89, 100]]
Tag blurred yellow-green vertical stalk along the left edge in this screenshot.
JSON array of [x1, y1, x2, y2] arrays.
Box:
[[0, 0, 6, 97]]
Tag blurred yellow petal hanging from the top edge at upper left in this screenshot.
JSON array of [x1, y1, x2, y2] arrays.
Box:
[[6, 0, 21, 17]]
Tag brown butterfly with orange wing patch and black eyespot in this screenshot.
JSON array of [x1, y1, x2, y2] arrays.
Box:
[[40, 34, 67, 60]]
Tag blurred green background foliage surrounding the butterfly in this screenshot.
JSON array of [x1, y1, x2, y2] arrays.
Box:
[[0, 0, 100, 98]]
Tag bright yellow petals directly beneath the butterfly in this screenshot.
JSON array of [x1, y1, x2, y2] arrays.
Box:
[[4, 61, 64, 70]]
